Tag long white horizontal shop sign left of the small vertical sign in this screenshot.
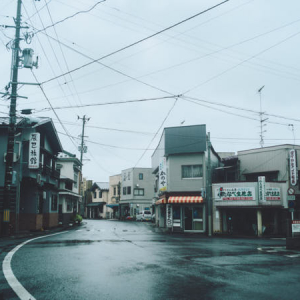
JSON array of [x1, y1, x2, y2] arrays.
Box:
[[216, 187, 255, 200]]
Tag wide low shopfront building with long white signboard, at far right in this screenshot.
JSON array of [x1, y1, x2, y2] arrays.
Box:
[[213, 145, 300, 236]]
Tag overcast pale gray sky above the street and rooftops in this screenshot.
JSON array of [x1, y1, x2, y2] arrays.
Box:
[[0, 0, 300, 181]]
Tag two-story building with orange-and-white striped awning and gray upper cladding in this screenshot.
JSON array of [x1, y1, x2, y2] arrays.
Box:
[[152, 125, 220, 232]]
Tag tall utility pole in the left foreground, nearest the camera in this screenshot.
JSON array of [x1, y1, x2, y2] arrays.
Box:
[[2, 0, 22, 236]]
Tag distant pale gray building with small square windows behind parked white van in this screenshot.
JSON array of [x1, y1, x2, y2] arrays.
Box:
[[120, 168, 154, 218]]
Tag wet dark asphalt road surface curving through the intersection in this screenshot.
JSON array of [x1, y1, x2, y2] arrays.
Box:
[[0, 220, 300, 300]]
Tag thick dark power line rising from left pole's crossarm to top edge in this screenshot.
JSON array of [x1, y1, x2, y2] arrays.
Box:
[[41, 0, 229, 84]]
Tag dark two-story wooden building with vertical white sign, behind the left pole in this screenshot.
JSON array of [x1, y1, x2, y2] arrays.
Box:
[[0, 118, 62, 232]]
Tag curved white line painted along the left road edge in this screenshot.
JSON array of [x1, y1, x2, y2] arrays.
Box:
[[2, 231, 68, 300]]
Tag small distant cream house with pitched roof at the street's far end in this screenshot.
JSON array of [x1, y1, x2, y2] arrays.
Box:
[[87, 182, 110, 219]]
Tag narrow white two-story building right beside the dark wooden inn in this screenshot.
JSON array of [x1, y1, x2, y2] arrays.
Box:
[[57, 151, 82, 224]]
